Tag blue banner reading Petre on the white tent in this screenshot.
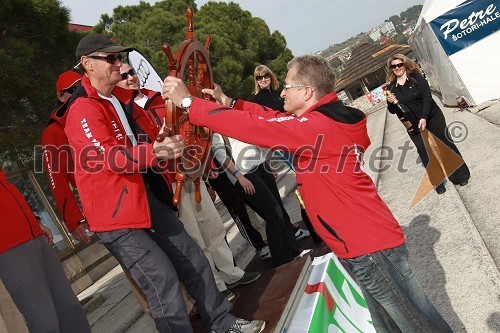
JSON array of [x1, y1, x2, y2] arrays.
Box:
[[429, 0, 500, 56]]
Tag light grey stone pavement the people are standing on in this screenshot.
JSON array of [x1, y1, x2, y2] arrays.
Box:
[[79, 97, 500, 333]]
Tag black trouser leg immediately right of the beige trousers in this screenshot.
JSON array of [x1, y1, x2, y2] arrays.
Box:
[[208, 171, 266, 251]]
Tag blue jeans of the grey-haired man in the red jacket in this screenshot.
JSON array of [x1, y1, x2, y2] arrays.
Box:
[[341, 244, 452, 333]]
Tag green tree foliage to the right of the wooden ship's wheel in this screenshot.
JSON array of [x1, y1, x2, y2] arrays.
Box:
[[198, 2, 293, 98]]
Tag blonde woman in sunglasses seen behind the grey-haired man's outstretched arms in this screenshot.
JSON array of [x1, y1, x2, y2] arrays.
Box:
[[252, 65, 285, 112]]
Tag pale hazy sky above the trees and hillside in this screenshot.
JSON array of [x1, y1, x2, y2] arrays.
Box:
[[61, 0, 424, 56]]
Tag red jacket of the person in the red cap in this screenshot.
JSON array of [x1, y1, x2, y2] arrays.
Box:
[[40, 105, 84, 232]]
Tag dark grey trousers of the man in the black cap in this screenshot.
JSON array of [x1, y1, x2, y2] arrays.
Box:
[[96, 191, 236, 333]]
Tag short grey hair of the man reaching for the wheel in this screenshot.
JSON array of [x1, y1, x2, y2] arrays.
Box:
[[287, 54, 335, 98]]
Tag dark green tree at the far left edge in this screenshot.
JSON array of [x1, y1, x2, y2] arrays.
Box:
[[0, 0, 80, 162]]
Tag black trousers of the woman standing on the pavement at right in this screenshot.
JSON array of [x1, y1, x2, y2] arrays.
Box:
[[410, 111, 470, 186]]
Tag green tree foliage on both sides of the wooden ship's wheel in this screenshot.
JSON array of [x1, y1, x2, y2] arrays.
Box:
[[94, 0, 292, 98]]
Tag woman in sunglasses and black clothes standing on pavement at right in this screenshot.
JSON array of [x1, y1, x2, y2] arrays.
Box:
[[386, 54, 470, 194]]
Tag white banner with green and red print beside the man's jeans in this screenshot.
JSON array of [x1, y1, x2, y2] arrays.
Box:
[[286, 253, 375, 333]]
